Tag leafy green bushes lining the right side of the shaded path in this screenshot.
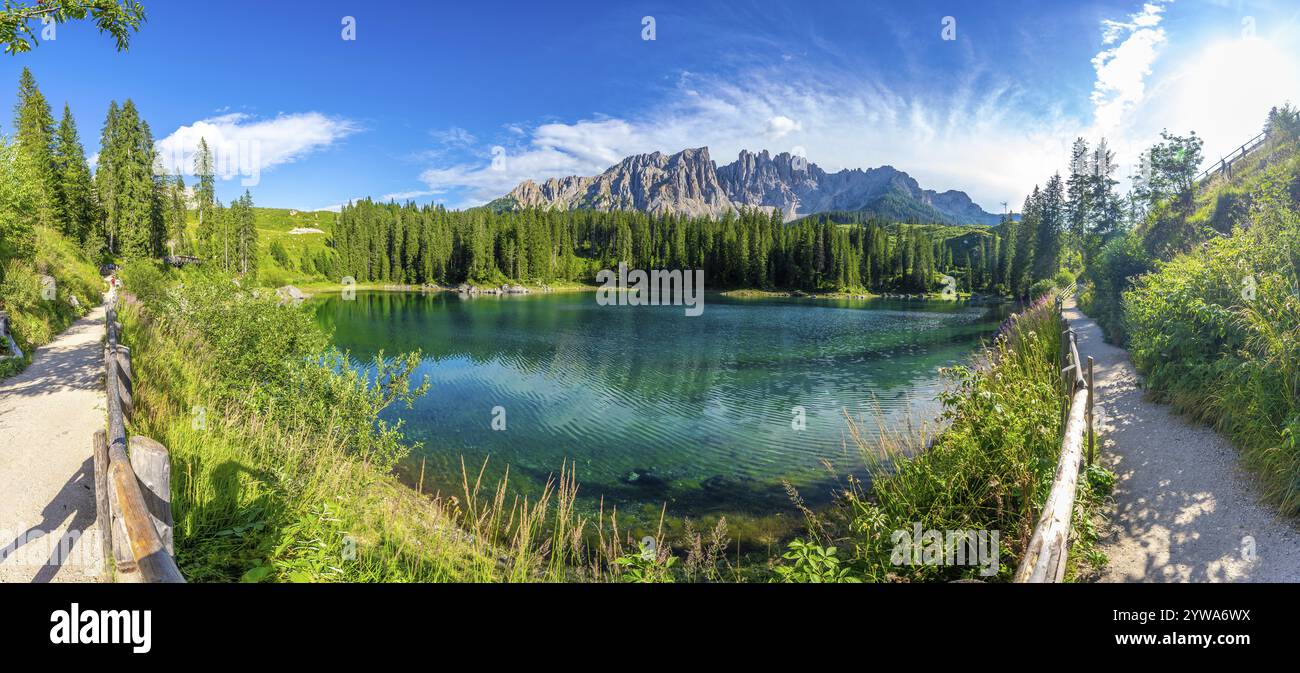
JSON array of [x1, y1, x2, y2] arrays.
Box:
[[1123, 170, 1300, 514]]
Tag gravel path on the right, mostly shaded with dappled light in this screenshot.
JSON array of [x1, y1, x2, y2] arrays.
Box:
[[1065, 305, 1300, 582]]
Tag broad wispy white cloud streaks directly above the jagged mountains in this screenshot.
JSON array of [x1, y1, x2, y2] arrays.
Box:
[[420, 75, 1078, 212]]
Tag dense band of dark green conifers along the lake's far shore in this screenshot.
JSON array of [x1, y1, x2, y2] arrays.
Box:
[[333, 199, 996, 292]]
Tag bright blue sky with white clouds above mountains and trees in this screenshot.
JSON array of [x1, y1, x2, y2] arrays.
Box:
[[0, 0, 1300, 210]]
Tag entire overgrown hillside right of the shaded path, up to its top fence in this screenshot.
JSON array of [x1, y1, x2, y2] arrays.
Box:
[[1083, 114, 1300, 514]]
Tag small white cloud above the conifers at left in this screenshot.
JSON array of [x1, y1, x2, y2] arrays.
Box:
[[156, 112, 360, 184]]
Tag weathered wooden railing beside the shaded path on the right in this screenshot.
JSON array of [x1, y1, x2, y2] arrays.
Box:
[[1015, 285, 1096, 582]]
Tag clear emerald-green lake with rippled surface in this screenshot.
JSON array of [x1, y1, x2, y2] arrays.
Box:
[[312, 292, 1006, 527]]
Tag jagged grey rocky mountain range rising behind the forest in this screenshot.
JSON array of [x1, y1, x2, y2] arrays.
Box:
[[489, 147, 1000, 225]]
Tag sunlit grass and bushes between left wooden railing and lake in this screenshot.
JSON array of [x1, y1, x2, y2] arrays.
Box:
[[121, 262, 759, 582]]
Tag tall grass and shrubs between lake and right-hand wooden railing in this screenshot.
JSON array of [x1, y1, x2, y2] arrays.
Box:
[[769, 296, 1109, 582]]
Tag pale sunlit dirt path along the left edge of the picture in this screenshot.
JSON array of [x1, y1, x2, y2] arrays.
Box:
[[0, 305, 105, 582]]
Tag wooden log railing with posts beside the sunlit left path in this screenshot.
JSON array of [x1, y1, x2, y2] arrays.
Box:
[[94, 292, 185, 582]]
